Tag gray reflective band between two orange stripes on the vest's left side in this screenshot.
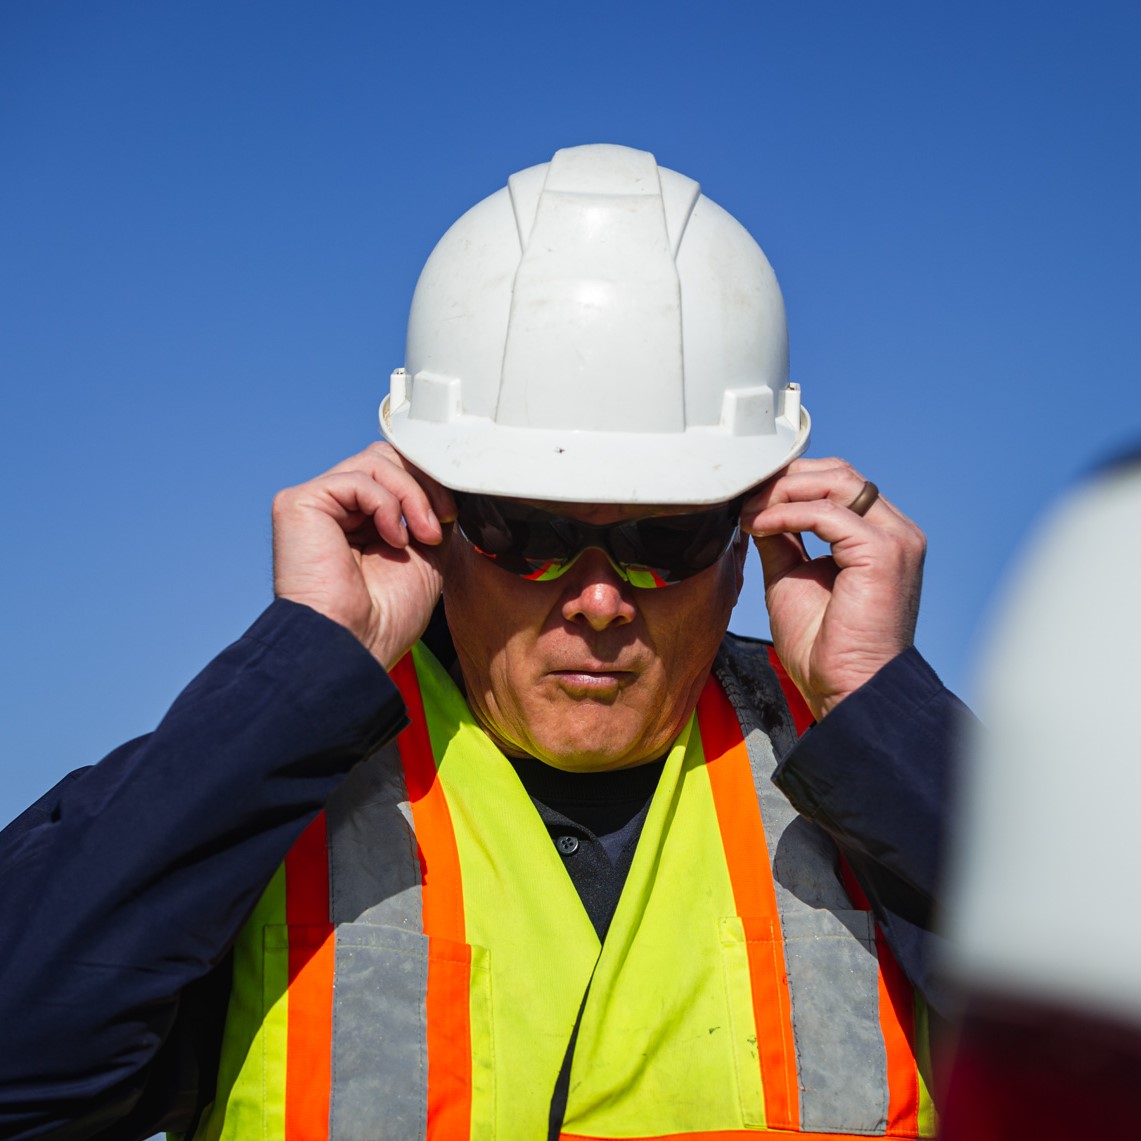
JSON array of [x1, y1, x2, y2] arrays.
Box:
[[325, 743, 428, 1141]]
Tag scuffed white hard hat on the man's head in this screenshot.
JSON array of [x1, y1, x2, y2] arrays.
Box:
[[380, 145, 809, 503]]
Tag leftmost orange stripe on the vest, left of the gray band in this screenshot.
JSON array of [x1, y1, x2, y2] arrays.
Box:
[[285, 812, 334, 1141]]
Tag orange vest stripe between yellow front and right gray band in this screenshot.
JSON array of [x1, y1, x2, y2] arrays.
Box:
[[690, 678, 800, 1136]]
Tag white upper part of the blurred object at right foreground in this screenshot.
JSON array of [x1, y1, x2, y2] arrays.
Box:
[[949, 449, 1141, 1023]]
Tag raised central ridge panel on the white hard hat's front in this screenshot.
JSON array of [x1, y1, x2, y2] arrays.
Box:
[[495, 146, 685, 432]]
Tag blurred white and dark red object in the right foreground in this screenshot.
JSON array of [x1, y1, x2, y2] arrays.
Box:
[[940, 455, 1141, 1141]]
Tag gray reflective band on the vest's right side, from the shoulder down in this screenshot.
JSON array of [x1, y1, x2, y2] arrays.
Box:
[[714, 636, 888, 1133]]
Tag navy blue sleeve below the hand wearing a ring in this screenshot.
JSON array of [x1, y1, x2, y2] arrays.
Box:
[[774, 649, 971, 1014]]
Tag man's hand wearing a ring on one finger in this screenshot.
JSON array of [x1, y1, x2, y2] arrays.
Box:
[[741, 460, 926, 720]]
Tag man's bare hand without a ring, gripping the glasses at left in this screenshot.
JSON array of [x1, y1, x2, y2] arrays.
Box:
[[273, 444, 455, 669]]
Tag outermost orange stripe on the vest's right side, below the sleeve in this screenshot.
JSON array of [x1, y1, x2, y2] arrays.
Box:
[[841, 860, 920, 1138]]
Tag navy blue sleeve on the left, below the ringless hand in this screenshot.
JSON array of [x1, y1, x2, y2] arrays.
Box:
[[0, 600, 405, 1138]]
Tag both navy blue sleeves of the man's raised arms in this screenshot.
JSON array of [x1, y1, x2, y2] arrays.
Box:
[[0, 600, 961, 1139]]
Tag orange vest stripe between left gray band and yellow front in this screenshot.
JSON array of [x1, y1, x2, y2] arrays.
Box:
[[390, 654, 471, 1141]]
